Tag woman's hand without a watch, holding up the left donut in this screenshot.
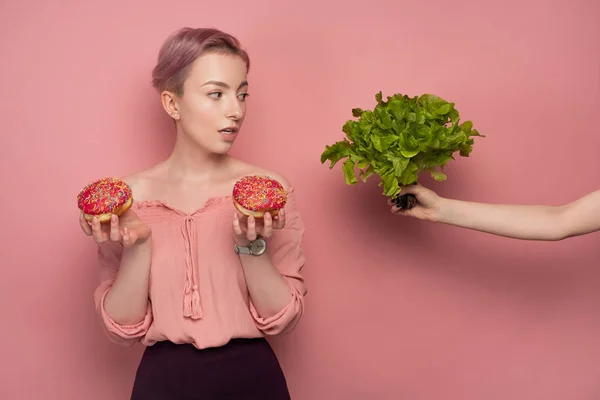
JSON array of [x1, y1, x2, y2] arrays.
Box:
[[79, 209, 152, 247]]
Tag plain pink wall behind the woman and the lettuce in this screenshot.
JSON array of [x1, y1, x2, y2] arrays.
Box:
[[0, 0, 600, 400]]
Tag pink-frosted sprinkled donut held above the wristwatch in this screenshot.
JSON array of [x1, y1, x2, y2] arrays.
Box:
[[233, 175, 287, 218]]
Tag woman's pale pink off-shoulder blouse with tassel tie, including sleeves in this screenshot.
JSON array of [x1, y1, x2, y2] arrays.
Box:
[[94, 188, 306, 349]]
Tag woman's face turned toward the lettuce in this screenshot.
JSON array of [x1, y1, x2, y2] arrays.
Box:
[[175, 53, 248, 154]]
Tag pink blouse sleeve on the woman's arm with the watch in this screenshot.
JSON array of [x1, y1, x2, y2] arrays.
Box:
[[250, 193, 307, 335]]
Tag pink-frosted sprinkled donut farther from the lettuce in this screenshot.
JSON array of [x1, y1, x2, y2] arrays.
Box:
[[77, 178, 133, 223]]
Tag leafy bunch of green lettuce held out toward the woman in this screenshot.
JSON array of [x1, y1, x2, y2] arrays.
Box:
[[321, 92, 485, 198]]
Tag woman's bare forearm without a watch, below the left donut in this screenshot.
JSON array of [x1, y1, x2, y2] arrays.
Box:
[[104, 239, 152, 325]]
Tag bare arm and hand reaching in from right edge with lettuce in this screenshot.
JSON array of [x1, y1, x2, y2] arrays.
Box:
[[388, 184, 600, 241]]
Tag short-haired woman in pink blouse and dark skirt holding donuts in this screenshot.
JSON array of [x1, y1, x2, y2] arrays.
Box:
[[80, 28, 306, 400]]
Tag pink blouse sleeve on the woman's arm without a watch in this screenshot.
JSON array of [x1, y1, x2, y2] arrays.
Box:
[[94, 242, 153, 346]]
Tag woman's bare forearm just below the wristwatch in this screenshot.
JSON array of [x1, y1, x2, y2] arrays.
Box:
[[240, 253, 292, 318]]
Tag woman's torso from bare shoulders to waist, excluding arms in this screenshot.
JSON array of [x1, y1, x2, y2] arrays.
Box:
[[125, 163, 282, 348]]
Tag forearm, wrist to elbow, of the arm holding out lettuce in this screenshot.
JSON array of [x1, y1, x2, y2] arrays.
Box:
[[437, 199, 569, 241]]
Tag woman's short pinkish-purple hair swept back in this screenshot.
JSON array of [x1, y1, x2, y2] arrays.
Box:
[[152, 28, 250, 96]]
